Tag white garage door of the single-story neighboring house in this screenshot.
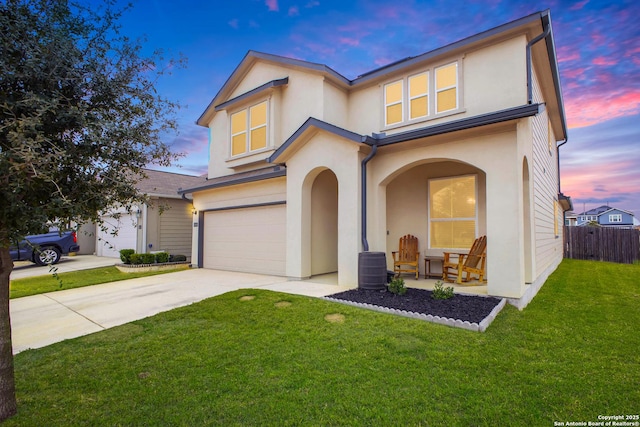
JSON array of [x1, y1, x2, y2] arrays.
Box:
[[96, 214, 138, 258]]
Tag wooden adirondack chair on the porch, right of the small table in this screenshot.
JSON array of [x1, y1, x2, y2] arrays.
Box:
[[442, 236, 487, 285]]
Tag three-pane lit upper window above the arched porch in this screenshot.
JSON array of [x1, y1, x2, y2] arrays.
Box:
[[384, 61, 460, 127]]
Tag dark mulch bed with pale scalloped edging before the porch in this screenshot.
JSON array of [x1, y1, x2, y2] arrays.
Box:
[[327, 288, 501, 323]]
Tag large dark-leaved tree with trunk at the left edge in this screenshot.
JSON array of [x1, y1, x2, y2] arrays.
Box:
[[0, 0, 182, 420]]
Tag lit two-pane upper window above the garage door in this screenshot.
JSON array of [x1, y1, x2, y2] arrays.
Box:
[[231, 101, 267, 156]]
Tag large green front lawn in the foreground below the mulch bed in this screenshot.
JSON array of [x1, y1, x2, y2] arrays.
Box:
[[6, 260, 640, 426]]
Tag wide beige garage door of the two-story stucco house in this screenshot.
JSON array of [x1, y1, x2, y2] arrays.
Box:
[[203, 205, 286, 276]]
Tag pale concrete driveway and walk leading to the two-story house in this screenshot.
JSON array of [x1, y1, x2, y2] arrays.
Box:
[[10, 270, 349, 354]]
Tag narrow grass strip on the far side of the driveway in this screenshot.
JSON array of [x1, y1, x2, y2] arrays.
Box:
[[9, 266, 189, 298]]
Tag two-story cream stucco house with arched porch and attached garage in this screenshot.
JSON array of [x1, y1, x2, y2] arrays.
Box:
[[181, 11, 571, 307]]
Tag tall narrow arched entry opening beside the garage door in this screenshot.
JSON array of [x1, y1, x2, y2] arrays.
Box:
[[310, 169, 338, 276]]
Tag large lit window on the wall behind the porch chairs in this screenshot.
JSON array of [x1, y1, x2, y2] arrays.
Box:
[[429, 175, 478, 249]]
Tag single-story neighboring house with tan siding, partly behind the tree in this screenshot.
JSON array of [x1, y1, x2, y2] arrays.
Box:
[[95, 169, 205, 258]]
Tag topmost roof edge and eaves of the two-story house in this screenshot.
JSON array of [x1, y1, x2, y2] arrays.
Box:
[[196, 10, 567, 140]]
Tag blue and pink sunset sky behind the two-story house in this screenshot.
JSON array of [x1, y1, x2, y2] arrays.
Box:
[[112, 0, 640, 217]]
